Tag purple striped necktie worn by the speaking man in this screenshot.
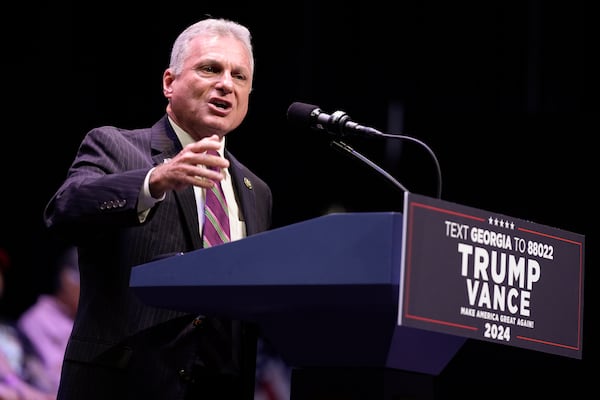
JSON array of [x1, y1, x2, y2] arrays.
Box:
[[202, 150, 230, 247]]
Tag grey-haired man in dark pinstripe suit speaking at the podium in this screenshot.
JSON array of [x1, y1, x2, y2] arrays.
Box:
[[44, 18, 272, 400]]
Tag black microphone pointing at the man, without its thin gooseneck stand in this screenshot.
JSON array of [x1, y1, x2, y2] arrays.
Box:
[[287, 102, 381, 136]]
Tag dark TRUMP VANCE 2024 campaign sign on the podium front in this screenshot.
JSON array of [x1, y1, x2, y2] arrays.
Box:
[[398, 193, 585, 359]]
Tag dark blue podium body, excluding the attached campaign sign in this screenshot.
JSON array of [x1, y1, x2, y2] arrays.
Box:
[[131, 212, 465, 400]]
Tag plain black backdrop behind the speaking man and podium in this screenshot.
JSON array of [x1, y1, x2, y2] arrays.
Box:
[[0, 0, 598, 398]]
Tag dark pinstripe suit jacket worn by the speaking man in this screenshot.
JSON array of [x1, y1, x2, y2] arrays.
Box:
[[44, 116, 272, 400]]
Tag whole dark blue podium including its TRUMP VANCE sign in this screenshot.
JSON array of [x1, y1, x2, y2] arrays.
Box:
[[130, 194, 584, 400]]
